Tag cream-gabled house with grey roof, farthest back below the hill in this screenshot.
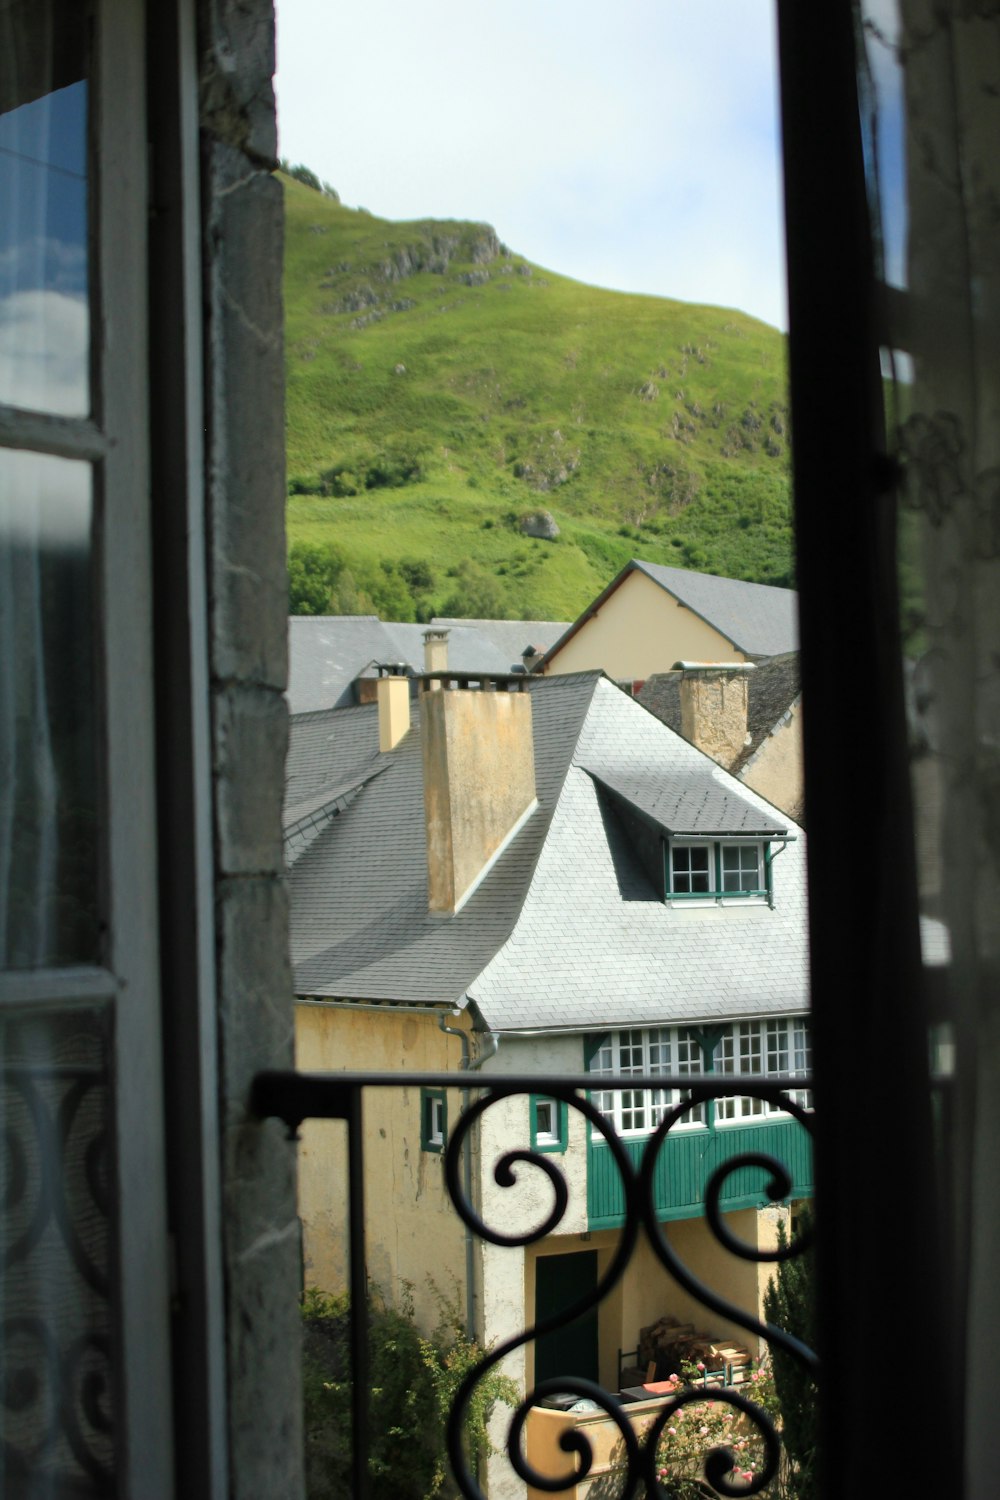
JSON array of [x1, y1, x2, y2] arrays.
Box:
[[537, 558, 799, 683]]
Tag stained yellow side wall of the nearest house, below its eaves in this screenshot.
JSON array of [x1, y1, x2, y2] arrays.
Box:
[[295, 1002, 465, 1328]]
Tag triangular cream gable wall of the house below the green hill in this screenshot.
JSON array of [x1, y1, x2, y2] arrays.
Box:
[[546, 573, 745, 681]]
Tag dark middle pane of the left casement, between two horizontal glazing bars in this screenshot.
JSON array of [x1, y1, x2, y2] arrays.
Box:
[[0, 449, 99, 969]]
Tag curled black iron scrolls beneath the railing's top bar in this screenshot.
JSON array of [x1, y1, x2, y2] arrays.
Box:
[[445, 1079, 819, 1500]]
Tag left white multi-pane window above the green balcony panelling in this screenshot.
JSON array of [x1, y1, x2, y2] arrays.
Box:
[[591, 1026, 705, 1136]]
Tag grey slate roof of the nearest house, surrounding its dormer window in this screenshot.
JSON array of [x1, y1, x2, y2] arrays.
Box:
[[289, 672, 808, 1032]]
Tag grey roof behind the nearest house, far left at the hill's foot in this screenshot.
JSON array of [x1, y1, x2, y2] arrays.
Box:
[[288, 615, 510, 714]]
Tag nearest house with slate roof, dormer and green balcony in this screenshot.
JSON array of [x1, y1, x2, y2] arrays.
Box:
[[286, 672, 813, 1494]]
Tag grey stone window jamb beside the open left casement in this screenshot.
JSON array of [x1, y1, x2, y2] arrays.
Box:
[[198, 0, 301, 1500]]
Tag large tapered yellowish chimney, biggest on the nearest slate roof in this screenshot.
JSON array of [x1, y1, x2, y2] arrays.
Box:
[[420, 674, 535, 914]]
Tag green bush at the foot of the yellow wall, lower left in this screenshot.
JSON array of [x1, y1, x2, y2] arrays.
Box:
[[303, 1290, 517, 1500]]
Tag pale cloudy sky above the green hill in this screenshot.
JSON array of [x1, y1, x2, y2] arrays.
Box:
[[276, 0, 787, 329]]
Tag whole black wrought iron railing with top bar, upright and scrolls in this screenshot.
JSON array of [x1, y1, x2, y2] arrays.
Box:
[[252, 1071, 817, 1500]]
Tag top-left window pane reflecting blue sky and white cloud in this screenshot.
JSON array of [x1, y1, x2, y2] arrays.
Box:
[[0, 0, 90, 416]]
